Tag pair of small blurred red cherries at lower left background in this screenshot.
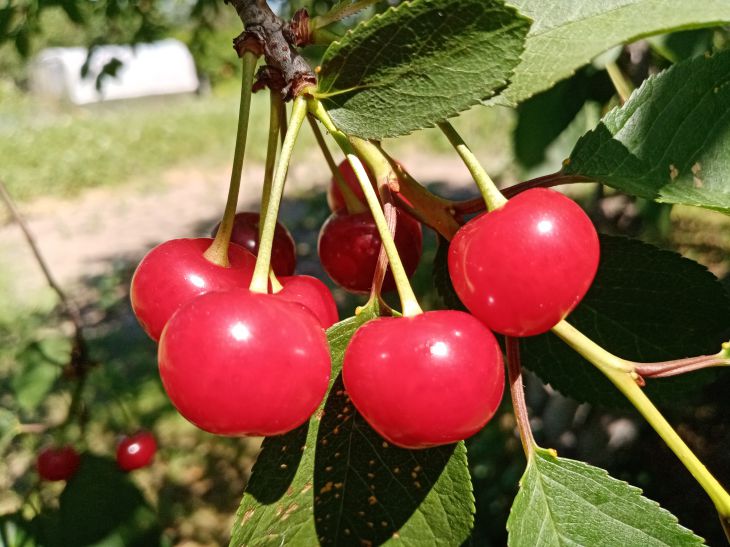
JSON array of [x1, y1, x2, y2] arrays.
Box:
[[36, 431, 157, 481]]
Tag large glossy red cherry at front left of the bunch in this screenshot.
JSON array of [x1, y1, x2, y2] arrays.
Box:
[[158, 289, 331, 436]]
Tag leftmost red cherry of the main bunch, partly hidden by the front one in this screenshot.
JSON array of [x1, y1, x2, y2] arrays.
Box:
[[130, 238, 256, 340]]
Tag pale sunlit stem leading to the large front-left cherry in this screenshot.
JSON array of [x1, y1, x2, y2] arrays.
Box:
[[249, 95, 307, 293]]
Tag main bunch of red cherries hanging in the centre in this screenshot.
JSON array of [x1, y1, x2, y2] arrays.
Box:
[[131, 156, 599, 449]]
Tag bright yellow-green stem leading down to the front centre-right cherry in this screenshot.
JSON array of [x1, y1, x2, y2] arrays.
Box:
[[309, 99, 422, 317]]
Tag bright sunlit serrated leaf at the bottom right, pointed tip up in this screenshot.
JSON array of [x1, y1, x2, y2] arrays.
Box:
[[507, 448, 703, 547]]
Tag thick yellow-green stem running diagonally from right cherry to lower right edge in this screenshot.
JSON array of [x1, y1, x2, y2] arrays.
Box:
[[552, 321, 730, 521]]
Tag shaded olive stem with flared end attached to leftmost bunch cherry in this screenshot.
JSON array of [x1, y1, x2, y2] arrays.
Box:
[[203, 51, 258, 268]]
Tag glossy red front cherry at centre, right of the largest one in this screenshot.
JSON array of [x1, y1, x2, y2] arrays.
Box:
[[342, 310, 504, 448]]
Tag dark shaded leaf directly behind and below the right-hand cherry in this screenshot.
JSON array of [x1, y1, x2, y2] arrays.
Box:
[[521, 235, 730, 407]]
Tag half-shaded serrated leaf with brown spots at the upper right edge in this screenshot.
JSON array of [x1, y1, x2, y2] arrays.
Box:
[[564, 50, 730, 213]]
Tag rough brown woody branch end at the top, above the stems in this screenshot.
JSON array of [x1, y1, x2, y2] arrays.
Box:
[[228, 0, 317, 100]]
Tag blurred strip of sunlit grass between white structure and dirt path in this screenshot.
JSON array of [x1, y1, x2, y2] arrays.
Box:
[[0, 76, 510, 201]]
